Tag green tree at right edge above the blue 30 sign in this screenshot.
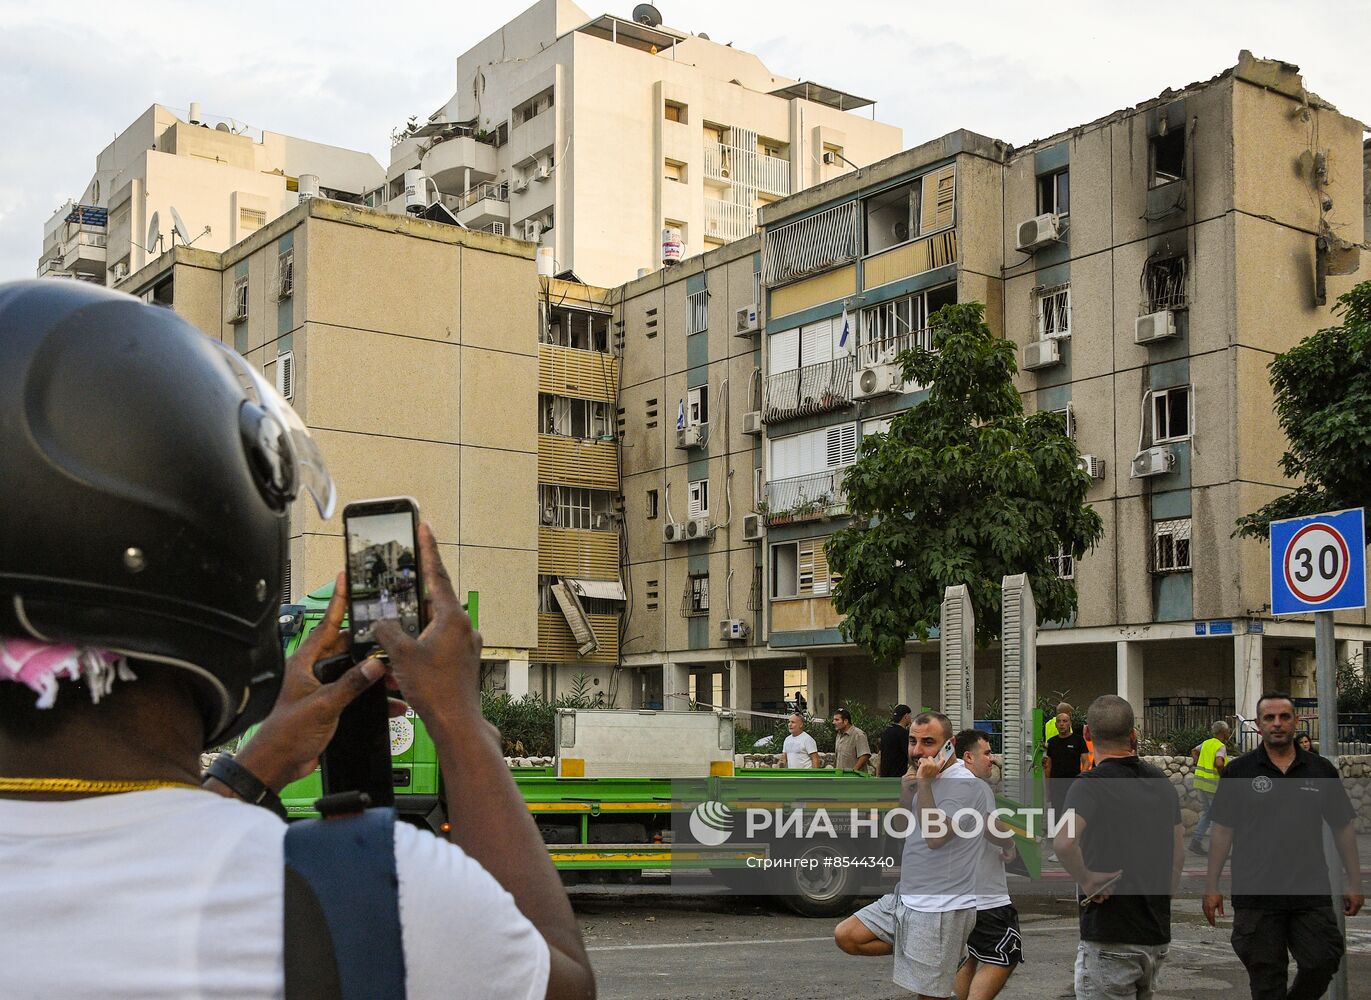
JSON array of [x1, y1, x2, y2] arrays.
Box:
[[1234, 281, 1371, 538]]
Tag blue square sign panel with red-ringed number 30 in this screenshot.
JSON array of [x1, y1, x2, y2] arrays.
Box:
[[1271, 508, 1367, 615]]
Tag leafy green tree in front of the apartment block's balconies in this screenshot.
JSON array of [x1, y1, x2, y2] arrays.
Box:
[[827, 303, 1104, 664]]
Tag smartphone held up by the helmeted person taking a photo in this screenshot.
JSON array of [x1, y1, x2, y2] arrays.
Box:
[[343, 497, 425, 663]]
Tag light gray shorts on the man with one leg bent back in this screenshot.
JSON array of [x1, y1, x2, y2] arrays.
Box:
[[857, 893, 976, 997]]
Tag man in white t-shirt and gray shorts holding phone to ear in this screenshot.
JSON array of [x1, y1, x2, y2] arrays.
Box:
[[834, 712, 1008, 1000]]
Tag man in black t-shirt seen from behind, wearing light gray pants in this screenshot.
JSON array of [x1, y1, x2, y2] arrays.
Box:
[[1054, 694, 1185, 1000]]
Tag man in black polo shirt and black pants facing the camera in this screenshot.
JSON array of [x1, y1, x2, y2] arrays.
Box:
[[1204, 693, 1363, 1000]]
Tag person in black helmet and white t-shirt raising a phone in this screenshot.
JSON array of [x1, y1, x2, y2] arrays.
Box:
[[0, 281, 595, 997]]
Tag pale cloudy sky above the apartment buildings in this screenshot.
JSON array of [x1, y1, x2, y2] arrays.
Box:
[[0, 0, 1371, 281]]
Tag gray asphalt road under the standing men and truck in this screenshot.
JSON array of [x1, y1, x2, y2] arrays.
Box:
[[570, 885, 1371, 1000]]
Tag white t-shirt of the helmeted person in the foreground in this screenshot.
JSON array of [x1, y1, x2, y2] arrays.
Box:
[[0, 789, 548, 1000]]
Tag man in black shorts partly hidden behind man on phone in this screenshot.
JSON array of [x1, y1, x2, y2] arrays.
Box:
[[956, 730, 1024, 1000]]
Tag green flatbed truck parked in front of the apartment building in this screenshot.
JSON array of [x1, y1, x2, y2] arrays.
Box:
[[259, 584, 1039, 916]]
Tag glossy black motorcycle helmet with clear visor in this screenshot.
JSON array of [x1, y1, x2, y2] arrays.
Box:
[[0, 278, 335, 746]]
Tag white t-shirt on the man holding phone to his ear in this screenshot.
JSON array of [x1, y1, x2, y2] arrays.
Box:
[[898, 760, 995, 914]]
